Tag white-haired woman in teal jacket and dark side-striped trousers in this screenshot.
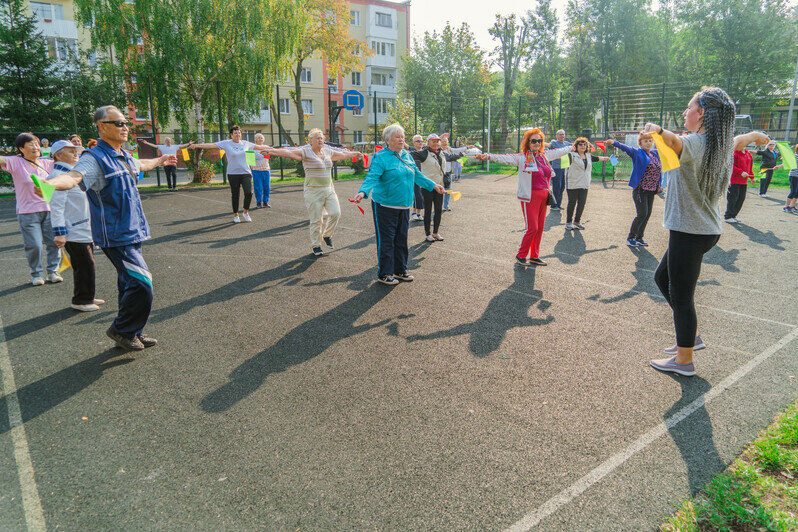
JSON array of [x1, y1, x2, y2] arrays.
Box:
[[352, 124, 444, 285]]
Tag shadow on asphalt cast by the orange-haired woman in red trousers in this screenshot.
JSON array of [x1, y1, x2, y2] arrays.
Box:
[[407, 265, 554, 358]]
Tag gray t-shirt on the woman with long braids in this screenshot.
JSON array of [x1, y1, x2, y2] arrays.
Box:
[[663, 133, 732, 235]]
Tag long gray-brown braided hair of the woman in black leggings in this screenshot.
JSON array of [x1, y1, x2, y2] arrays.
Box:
[[693, 87, 735, 204]]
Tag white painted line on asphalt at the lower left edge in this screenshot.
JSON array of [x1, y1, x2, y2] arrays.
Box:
[[0, 316, 47, 530]]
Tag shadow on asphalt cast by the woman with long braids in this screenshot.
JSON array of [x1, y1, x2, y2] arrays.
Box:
[[663, 373, 727, 495]]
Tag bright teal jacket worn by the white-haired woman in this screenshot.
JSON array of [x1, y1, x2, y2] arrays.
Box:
[[360, 148, 435, 209]]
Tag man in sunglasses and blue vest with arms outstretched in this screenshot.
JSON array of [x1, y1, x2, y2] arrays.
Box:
[[43, 105, 177, 351]]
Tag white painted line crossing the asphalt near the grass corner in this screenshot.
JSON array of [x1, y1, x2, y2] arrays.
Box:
[[505, 328, 798, 532]]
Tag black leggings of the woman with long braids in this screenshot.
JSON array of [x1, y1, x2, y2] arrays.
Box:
[[654, 231, 720, 347]]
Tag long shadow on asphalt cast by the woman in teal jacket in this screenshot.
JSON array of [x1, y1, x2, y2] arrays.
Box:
[[200, 269, 409, 413]]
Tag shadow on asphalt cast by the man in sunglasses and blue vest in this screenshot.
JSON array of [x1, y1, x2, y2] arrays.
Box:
[[0, 347, 134, 434]]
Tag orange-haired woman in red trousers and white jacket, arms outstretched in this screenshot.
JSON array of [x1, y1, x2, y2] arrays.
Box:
[[477, 128, 574, 266]]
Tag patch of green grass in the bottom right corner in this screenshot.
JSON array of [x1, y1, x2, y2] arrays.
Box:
[[660, 402, 798, 532]]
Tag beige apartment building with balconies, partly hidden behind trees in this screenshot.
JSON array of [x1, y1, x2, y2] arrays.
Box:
[[23, 0, 410, 145]]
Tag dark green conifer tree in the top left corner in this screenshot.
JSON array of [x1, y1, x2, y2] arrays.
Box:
[[0, 0, 58, 132]]
